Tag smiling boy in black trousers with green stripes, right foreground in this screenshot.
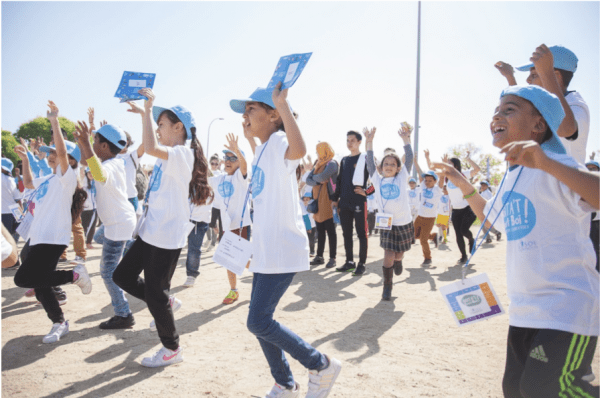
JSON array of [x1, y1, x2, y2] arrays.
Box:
[[434, 86, 600, 398]]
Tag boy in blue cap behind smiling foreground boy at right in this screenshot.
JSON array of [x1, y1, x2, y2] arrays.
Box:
[[495, 44, 590, 163]]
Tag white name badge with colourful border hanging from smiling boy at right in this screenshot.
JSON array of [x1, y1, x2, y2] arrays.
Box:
[[440, 273, 505, 326]]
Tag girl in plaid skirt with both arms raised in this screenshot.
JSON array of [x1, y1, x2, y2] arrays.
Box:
[[363, 127, 415, 301]]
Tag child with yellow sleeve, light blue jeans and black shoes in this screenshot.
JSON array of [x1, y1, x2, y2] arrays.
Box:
[[75, 121, 136, 329]]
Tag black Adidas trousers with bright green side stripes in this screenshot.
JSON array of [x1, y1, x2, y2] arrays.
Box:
[[502, 326, 600, 398]]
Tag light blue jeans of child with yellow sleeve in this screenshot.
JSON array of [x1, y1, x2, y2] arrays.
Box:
[[100, 237, 131, 317]]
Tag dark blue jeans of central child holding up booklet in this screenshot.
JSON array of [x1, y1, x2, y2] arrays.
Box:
[[247, 273, 327, 388]]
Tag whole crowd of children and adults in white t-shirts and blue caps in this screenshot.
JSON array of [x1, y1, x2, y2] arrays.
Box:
[[2, 45, 600, 398]]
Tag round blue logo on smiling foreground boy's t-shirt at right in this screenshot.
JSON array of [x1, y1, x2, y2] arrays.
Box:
[[502, 192, 535, 241]]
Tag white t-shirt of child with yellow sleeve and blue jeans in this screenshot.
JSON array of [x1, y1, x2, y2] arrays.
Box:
[[96, 158, 137, 241]]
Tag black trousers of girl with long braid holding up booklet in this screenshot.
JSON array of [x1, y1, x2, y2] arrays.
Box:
[[113, 237, 181, 350]]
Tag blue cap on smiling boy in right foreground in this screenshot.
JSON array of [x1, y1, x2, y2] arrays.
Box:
[[500, 86, 567, 154]]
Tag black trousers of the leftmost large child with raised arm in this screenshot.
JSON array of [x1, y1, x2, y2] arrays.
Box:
[[15, 244, 73, 323]]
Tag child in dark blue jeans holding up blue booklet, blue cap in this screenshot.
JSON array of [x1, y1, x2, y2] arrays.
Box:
[[230, 83, 341, 398]]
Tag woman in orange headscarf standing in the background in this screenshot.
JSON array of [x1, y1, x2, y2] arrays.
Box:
[[306, 142, 338, 268]]
